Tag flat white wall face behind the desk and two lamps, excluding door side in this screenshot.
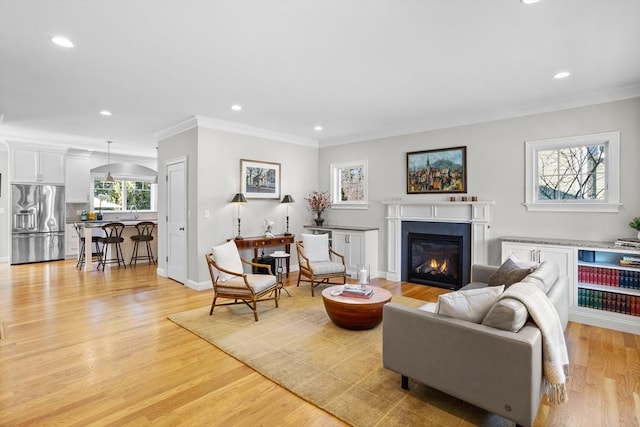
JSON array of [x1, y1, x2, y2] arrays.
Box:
[[196, 128, 318, 283]]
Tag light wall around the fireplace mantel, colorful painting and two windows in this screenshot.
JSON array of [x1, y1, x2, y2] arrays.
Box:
[[319, 98, 640, 269]]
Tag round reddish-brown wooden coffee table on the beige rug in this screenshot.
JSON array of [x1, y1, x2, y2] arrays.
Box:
[[322, 285, 391, 330]]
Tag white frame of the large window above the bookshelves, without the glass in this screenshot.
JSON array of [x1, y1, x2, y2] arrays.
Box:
[[524, 132, 622, 212]]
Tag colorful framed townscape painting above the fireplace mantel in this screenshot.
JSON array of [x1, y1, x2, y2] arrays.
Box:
[[407, 147, 467, 194]]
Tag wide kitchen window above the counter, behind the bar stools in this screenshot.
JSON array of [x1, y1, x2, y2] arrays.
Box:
[[93, 179, 156, 211]]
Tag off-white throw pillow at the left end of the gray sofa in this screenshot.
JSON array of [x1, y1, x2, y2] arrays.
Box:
[[436, 286, 504, 323]]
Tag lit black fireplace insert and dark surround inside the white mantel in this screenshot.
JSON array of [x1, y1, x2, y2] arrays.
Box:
[[401, 221, 471, 290]]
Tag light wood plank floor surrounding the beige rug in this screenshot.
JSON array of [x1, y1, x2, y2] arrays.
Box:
[[0, 260, 640, 426]]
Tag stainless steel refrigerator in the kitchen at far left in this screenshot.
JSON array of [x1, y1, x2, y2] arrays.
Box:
[[11, 184, 65, 264]]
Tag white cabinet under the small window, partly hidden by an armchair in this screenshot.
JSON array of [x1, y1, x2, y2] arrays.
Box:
[[305, 226, 380, 278]]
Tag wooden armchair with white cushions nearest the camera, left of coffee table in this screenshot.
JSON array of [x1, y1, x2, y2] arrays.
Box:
[[205, 241, 278, 322]]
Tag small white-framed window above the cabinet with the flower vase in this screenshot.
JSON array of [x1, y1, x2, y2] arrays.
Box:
[[331, 160, 369, 209]]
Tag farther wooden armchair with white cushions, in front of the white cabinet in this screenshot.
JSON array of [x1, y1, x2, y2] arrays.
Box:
[[296, 234, 347, 296]]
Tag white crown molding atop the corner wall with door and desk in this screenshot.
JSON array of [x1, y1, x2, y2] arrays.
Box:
[[154, 115, 318, 148]]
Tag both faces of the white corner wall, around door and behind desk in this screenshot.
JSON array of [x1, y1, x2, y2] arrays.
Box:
[[158, 127, 318, 287]]
